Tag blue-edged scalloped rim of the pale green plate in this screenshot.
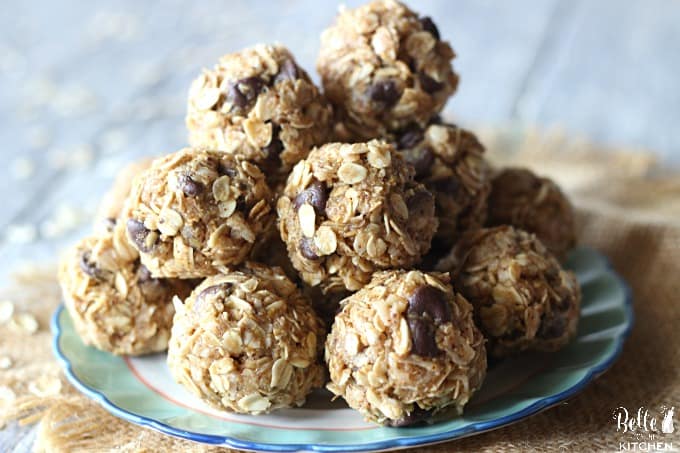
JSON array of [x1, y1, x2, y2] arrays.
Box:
[[50, 247, 635, 452]]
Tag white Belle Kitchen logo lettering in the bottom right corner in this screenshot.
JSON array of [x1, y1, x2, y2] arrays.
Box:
[[612, 406, 675, 452]]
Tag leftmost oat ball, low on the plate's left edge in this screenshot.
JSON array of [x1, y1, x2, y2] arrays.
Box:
[[59, 228, 192, 355]]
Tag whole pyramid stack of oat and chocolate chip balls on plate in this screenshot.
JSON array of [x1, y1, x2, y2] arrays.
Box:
[[60, 0, 580, 426]]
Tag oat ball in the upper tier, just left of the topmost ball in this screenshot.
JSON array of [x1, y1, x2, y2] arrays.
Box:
[[186, 44, 332, 181]]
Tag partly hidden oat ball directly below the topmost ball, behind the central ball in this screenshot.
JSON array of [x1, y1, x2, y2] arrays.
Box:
[[396, 123, 491, 248]]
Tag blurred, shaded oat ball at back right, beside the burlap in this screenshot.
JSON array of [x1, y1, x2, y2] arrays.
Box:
[[489, 168, 576, 258]]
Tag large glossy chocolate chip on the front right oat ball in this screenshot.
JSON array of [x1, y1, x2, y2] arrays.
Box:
[[406, 285, 452, 357]]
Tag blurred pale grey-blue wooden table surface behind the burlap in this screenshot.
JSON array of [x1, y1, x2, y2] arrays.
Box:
[[0, 0, 680, 451]]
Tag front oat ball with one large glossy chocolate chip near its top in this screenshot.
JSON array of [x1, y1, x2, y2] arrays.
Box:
[[326, 270, 486, 426]]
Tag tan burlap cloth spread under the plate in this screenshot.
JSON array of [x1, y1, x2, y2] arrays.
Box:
[[0, 131, 680, 452]]
